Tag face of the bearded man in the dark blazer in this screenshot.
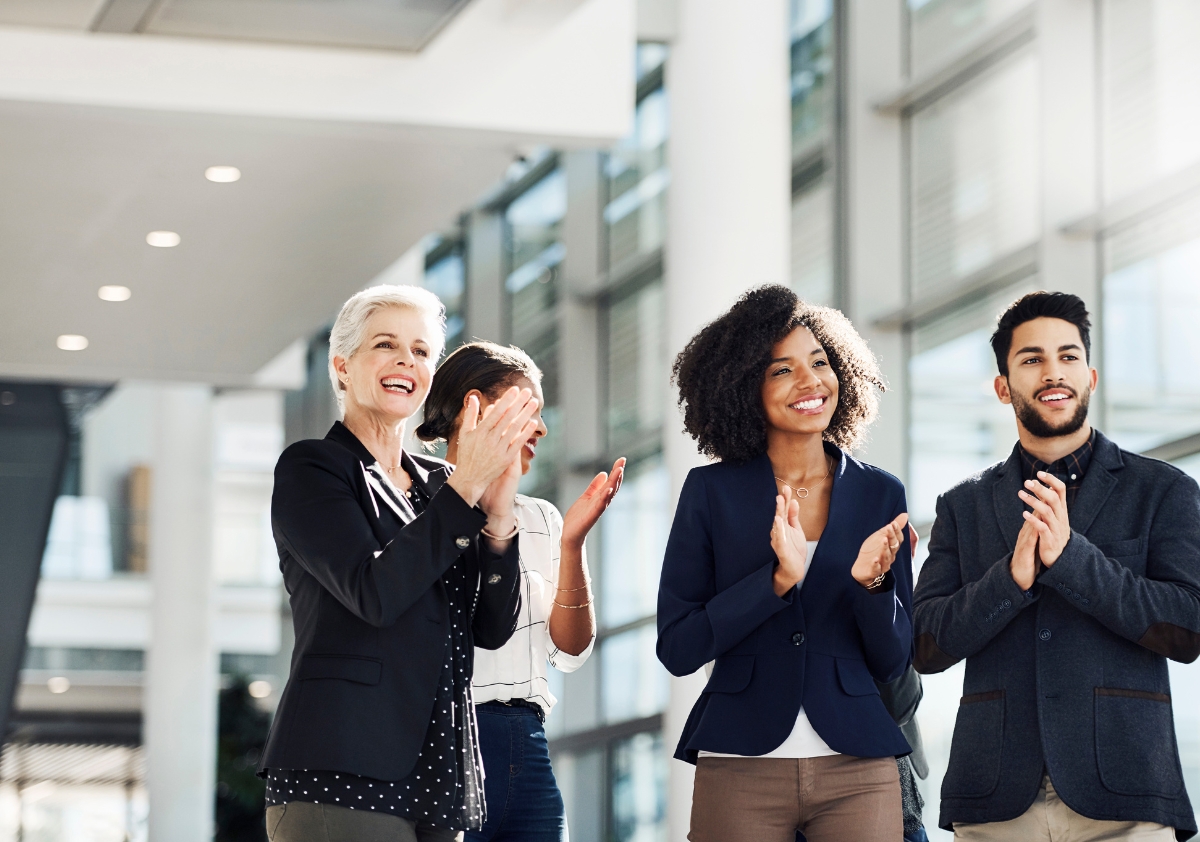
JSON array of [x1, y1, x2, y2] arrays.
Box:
[[996, 317, 1097, 439]]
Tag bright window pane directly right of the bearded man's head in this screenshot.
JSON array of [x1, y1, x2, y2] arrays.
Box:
[[1098, 199, 1200, 451]]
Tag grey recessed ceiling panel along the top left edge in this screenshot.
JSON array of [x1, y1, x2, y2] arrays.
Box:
[[0, 0, 467, 50]]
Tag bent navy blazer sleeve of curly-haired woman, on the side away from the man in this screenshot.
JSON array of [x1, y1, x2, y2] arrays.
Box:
[[656, 469, 794, 675]]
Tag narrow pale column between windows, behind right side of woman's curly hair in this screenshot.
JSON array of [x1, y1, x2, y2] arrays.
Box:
[[838, 0, 907, 477]]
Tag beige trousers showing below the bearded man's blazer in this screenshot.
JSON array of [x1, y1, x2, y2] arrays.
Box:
[[954, 776, 1175, 842]]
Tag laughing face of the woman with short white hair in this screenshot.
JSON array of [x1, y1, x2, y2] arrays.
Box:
[[334, 307, 440, 423]]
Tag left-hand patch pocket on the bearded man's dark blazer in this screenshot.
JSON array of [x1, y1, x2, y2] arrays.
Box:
[[942, 690, 1004, 798]]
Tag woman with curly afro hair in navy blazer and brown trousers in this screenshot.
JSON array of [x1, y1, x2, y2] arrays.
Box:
[[658, 285, 916, 842]]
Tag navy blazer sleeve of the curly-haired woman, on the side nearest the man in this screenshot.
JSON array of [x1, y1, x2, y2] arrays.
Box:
[[853, 491, 912, 682]]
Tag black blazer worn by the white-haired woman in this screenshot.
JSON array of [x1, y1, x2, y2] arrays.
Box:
[[260, 422, 521, 781]]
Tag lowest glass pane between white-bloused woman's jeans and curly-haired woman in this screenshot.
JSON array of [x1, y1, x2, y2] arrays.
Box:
[[610, 732, 667, 842]]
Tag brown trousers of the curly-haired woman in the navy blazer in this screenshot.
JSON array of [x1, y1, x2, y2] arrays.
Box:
[[688, 754, 904, 842]]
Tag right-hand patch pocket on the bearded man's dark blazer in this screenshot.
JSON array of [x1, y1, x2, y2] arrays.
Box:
[[1096, 687, 1183, 798]]
